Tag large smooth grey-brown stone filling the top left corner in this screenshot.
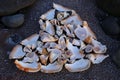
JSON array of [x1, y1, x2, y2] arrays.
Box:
[[0, 0, 36, 16]]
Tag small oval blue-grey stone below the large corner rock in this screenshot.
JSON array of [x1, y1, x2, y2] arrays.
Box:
[[1, 14, 24, 28]]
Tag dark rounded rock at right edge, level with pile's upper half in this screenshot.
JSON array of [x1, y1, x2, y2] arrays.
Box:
[[101, 17, 120, 36]]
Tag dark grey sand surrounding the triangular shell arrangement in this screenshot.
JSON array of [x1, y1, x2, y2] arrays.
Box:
[[0, 0, 120, 80]]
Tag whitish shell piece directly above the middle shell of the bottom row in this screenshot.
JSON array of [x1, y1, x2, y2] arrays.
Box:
[[49, 49, 62, 63]]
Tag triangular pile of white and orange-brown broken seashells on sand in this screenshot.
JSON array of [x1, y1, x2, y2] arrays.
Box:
[[9, 3, 109, 73]]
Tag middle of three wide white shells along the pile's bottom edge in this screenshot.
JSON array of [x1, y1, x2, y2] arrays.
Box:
[[41, 61, 63, 73]]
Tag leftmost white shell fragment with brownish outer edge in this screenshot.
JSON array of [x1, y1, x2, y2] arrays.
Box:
[[9, 45, 26, 59]]
